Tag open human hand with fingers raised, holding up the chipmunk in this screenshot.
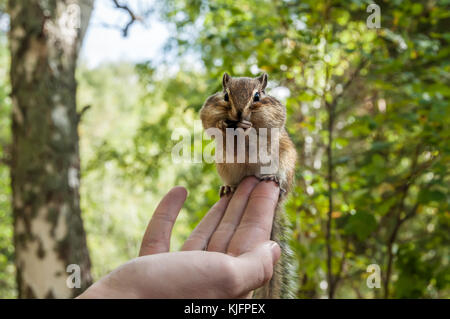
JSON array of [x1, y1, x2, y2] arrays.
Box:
[[78, 177, 280, 298]]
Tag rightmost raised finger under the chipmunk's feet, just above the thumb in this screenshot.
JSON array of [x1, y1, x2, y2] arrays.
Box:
[[228, 181, 280, 256]]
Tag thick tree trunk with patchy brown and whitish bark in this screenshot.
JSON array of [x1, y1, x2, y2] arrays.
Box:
[[8, 0, 93, 298]]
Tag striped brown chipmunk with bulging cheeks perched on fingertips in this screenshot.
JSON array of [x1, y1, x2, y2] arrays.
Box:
[[200, 73, 297, 298]]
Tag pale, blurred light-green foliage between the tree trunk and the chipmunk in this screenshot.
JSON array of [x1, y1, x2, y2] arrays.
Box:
[[77, 63, 215, 279]]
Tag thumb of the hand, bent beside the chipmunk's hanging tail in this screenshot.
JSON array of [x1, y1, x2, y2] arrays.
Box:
[[237, 241, 281, 294]]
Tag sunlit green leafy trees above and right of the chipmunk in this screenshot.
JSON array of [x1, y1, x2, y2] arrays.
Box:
[[153, 0, 450, 298]]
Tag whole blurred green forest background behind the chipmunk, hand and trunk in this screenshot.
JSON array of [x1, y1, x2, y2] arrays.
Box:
[[0, 0, 450, 298]]
